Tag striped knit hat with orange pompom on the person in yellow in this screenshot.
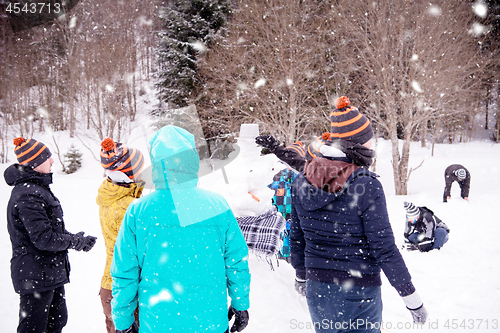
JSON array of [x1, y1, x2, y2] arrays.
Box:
[[101, 138, 144, 179]]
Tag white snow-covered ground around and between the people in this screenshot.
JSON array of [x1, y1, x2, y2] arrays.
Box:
[[0, 126, 500, 333]]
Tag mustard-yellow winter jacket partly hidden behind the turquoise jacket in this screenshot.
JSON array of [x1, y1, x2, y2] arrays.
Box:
[[96, 179, 144, 290]]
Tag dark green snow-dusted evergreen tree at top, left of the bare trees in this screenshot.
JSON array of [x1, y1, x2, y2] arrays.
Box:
[[152, 0, 231, 116]]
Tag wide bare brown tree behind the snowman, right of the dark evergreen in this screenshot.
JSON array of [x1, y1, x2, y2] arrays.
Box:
[[197, 0, 343, 143]]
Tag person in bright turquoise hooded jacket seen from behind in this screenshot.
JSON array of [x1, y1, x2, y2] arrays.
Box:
[[111, 126, 250, 333]]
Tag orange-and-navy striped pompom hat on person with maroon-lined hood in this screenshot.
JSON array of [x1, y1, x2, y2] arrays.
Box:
[[330, 96, 373, 144]]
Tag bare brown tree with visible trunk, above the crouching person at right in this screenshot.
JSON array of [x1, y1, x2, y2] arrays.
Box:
[[333, 0, 488, 195]]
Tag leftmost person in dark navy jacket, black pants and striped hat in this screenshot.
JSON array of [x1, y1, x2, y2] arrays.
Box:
[[4, 138, 96, 333]]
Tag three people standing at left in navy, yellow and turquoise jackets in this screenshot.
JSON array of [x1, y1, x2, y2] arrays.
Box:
[[4, 126, 250, 333]]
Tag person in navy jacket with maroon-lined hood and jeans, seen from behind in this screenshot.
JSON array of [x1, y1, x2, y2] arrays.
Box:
[[290, 96, 427, 332]]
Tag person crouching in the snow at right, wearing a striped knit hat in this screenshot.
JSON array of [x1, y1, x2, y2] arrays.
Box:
[[404, 201, 450, 252]]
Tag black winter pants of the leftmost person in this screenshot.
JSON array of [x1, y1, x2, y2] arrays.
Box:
[[17, 286, 68, 333]]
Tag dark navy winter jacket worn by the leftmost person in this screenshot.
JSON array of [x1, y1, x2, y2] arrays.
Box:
[[4, 164, 74, 294]]
